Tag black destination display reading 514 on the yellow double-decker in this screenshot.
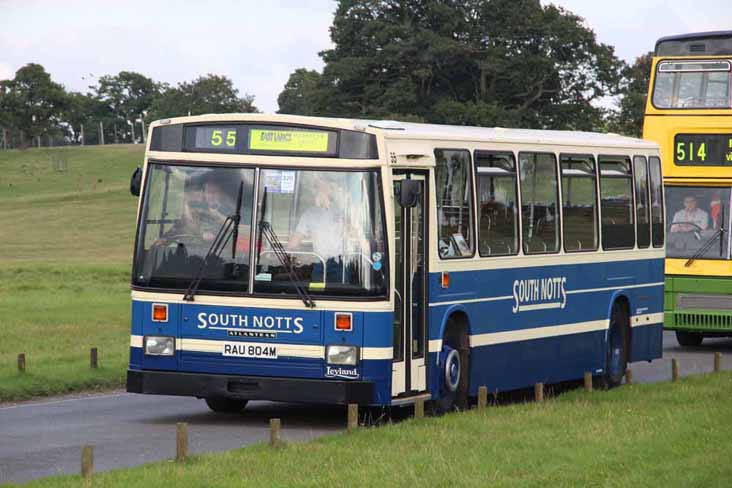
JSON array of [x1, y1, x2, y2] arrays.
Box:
[[674, 134, 732, 166]]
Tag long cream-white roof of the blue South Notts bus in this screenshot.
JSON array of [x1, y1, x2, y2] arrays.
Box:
[[151, 114, 658, 149]]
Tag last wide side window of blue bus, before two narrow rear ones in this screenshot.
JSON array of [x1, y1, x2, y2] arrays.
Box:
[[599, 156, 635, 249]]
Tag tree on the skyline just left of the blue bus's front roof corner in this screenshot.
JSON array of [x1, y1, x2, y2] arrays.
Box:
[[96, 71, 161, 139]]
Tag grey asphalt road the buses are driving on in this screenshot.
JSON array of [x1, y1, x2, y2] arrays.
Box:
[[0, 332, 732, 483]]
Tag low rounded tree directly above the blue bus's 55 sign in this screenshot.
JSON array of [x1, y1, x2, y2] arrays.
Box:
[[149, 74, 258, 120]]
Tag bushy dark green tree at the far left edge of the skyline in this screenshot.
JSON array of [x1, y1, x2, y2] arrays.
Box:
[[0, 63, 67, 144]]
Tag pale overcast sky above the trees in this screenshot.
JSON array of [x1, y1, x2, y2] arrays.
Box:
[[0, 0, 732, 112]]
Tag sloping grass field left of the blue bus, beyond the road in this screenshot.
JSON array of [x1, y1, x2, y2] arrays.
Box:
[[0, 145, 144, 401]]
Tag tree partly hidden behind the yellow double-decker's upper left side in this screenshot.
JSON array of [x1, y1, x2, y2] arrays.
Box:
[[610, 51, 653, 137]]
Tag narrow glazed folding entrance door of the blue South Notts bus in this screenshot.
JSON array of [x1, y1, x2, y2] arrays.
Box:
[[391, 172, 427, 397]]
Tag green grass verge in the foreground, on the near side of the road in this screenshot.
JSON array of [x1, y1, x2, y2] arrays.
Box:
[[17, 373, 732, 488]]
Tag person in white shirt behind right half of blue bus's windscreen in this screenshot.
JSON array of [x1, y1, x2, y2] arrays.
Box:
[[287, 176, 346, 283]]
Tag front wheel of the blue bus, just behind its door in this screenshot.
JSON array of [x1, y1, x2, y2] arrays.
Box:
[[436, 321, 470, 413]]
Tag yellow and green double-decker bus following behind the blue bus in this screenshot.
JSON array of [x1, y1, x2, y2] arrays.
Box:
[[643, 31, 732, 346]]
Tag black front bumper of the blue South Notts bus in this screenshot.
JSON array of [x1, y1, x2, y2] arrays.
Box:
[[127, 369, 375, 405]]
